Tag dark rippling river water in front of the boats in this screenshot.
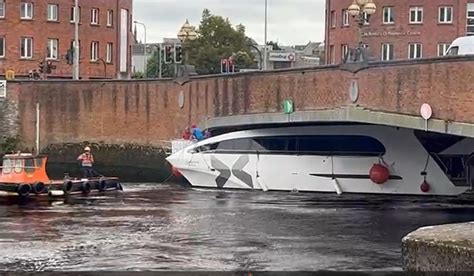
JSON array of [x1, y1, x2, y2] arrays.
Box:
[[0, 184, 474, 271]]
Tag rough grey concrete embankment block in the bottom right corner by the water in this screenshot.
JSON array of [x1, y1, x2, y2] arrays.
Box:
[[402, 222, 474, 272]]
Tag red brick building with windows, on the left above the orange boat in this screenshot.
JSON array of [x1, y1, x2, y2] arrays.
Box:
[[0, 0, 133, 78]]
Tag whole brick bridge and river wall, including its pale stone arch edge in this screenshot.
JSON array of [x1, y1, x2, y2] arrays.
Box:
[[0, 56, 474, 180]]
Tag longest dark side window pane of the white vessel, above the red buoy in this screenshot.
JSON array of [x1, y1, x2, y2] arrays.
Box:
[[298, 135, 386, 156]]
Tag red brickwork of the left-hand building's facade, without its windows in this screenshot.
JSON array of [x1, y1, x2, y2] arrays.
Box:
[[0, 0, 133, 78]]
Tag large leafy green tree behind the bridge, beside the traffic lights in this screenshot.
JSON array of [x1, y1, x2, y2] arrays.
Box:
[[184, 9, 256, 75]]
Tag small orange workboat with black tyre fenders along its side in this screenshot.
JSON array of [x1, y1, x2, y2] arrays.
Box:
[[0, 153, 123, 197]]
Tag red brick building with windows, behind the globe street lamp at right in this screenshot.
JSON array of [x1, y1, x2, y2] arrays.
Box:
[[325, 0, 474, 64]]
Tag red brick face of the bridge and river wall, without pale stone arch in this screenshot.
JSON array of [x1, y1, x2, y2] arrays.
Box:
[[8, 58, 474, 150]]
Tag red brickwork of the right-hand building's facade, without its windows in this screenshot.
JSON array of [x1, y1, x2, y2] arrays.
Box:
[[326, 0, 474, 64]]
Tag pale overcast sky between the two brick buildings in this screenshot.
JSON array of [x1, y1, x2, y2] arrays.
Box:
[[134, 0, 325, 45]]
